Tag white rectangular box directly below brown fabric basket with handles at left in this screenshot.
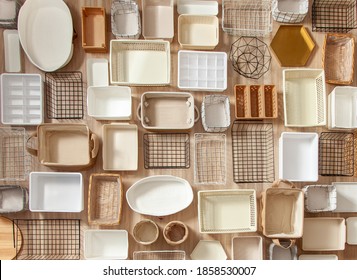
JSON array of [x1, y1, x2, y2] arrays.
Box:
[[29, 172, 84, 212]]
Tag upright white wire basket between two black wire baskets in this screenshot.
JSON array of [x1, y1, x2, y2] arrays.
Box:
[[194, 133, 226, 184]]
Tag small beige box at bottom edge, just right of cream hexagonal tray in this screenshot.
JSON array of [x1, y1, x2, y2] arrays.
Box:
[[232, 236, 263, 260]]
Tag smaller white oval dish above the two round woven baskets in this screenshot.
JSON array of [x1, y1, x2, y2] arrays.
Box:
[[126, 175, 193, 216]]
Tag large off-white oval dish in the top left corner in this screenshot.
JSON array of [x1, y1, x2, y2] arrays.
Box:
[[18, 0, 73, 72]]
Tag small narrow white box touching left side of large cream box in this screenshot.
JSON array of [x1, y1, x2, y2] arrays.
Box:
[[87, 58, 109, 87]]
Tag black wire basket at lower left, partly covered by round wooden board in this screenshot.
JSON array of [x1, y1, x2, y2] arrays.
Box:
[[14, 219, 81, 260]]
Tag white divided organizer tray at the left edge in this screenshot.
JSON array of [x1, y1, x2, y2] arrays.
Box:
[[1, 73, 43, 125]]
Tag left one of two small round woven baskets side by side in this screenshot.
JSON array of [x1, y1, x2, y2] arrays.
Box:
[[133, 219, 159, 245]]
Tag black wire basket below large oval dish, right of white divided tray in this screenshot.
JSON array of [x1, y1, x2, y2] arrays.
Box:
[[45, 71, 84, 119]]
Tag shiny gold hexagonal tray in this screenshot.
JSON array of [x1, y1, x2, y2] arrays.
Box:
[[270, 25, 315, 67]]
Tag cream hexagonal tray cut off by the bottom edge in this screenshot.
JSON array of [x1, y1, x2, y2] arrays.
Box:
[[190, 240, 227, 260]]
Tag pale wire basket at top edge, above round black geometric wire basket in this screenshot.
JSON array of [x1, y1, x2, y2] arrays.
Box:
[[222, 0, 273, 37]]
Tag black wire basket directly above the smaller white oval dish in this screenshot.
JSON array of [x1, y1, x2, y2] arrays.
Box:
[[143, 133, 190, 169]]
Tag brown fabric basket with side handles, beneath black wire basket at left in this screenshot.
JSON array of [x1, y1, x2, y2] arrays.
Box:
[[26, 123, 99, 171]]
